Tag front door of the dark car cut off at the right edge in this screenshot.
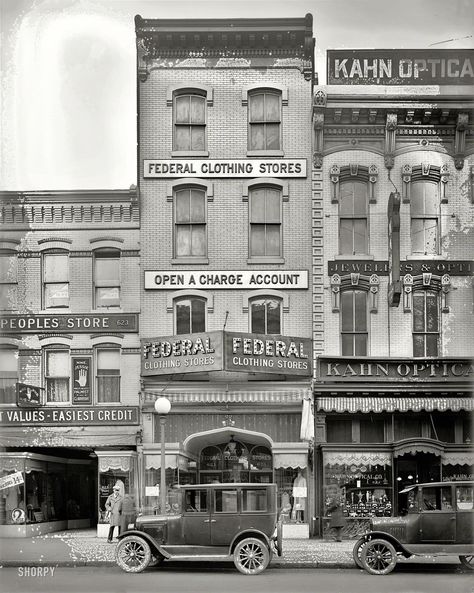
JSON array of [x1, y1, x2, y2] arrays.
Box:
[[420, 486, 456, 544]]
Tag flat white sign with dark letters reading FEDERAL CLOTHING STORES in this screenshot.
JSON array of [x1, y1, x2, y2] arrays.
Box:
[[143, 159, 306, 179]]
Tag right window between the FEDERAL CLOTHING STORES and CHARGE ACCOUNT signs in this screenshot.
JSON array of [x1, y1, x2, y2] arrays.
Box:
[[249, 187, 283, 257]]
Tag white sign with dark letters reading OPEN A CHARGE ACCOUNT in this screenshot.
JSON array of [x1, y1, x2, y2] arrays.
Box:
[[145, 270, 308, 290]]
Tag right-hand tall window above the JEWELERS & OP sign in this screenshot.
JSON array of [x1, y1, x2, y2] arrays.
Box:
[[410, 181, 439, 255]]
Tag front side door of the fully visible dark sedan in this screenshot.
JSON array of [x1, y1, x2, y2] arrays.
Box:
[[183, 488, 211, 546]]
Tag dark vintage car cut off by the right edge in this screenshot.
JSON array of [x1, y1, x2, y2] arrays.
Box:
[[353, 481, 474, 575]]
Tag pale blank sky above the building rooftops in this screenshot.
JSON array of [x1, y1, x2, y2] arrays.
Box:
[[0, 0, 474, 190]]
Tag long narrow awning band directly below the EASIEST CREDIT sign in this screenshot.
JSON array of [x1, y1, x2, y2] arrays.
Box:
[[0, 426, 138, 449]]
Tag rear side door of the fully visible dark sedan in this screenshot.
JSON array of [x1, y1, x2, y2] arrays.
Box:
[[211, 484, 240, 546]]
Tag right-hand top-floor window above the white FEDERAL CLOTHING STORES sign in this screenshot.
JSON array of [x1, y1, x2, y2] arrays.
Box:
[[248, 90, 281, 151]]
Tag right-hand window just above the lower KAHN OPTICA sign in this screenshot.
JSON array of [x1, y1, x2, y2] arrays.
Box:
[[413, 290, 439, 356]]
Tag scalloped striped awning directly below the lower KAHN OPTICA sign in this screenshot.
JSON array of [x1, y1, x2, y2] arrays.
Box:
[[315, 396, 474, 413]]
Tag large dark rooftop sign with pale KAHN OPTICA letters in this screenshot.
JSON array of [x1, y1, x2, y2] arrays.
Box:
[[327, 48, 474, 85]]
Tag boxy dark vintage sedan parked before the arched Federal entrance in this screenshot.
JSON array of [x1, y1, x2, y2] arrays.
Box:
[[115, 483, 282, 575]]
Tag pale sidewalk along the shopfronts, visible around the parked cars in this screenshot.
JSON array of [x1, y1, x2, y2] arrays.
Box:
[[0, 530, 459, 568]]
